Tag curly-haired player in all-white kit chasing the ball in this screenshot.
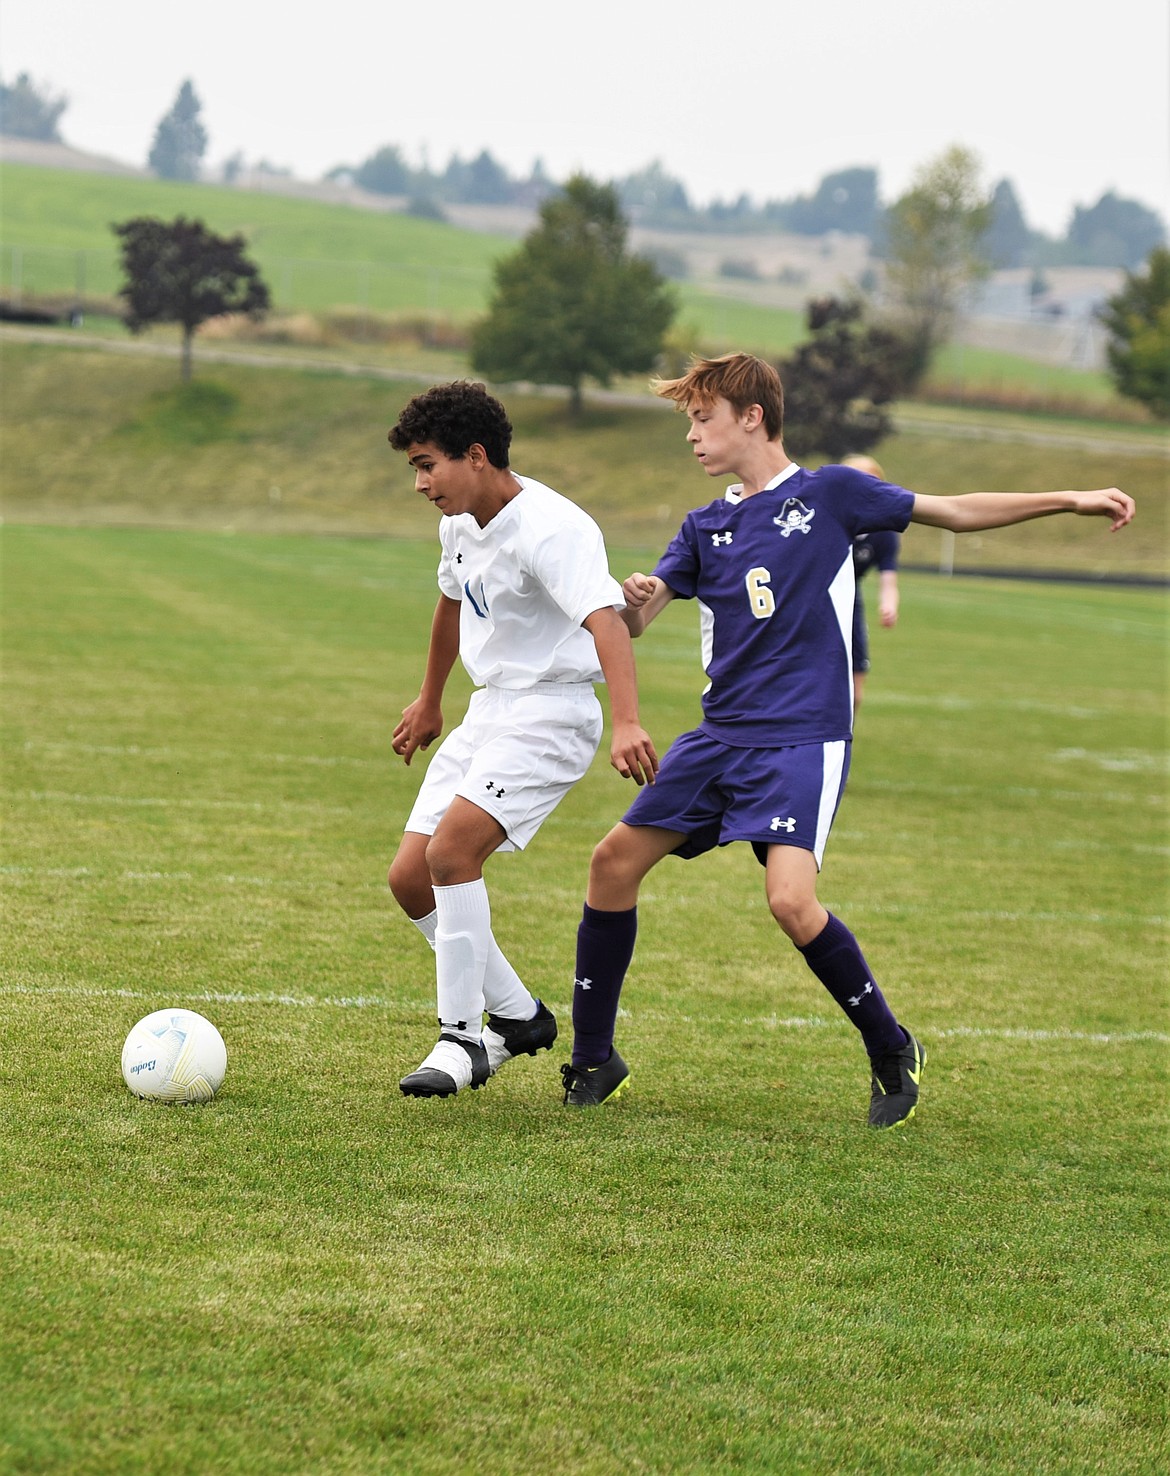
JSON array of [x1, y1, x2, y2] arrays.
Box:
[[390, 382, 658, 1097]]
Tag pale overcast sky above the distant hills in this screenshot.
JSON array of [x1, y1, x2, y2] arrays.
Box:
[[0, 0, 1170, 235]]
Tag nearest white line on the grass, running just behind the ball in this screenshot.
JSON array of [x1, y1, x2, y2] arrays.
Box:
[[0, 984, 1170, 1045]]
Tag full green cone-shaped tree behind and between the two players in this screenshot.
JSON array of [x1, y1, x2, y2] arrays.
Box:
[[472, 174, 676, 415]]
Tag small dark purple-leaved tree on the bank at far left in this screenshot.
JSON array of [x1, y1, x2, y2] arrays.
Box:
[[114, 215, 270, 384]]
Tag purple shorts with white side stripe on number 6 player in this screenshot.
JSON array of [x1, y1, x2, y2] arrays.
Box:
[[623, 728, 851, 866]]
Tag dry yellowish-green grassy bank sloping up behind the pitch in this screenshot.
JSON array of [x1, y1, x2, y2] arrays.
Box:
[[0, 339, 1170, 576]]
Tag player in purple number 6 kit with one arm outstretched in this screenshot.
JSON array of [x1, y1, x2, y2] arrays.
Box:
[[561, 354, 1133, 1128]]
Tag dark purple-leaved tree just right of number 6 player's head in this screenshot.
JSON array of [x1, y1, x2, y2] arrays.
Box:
[[776, 297, 925, 461]]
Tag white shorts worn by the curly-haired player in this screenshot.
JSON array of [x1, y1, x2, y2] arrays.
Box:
[[406, 682, 605, 850]]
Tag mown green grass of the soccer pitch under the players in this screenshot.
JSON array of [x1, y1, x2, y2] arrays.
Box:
[[0, 516, 1170, 1476]]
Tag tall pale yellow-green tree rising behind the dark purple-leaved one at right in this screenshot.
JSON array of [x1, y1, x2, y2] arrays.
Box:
[[885, 146, 993, 353]]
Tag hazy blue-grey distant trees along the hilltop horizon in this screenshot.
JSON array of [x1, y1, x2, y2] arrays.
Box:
[[0, 72, 1167, 276]]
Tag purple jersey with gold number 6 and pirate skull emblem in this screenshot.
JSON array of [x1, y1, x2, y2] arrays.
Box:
[[654, 466, 913, 748]]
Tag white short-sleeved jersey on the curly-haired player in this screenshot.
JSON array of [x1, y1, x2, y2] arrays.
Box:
[[438, 477, 626, 691]]
